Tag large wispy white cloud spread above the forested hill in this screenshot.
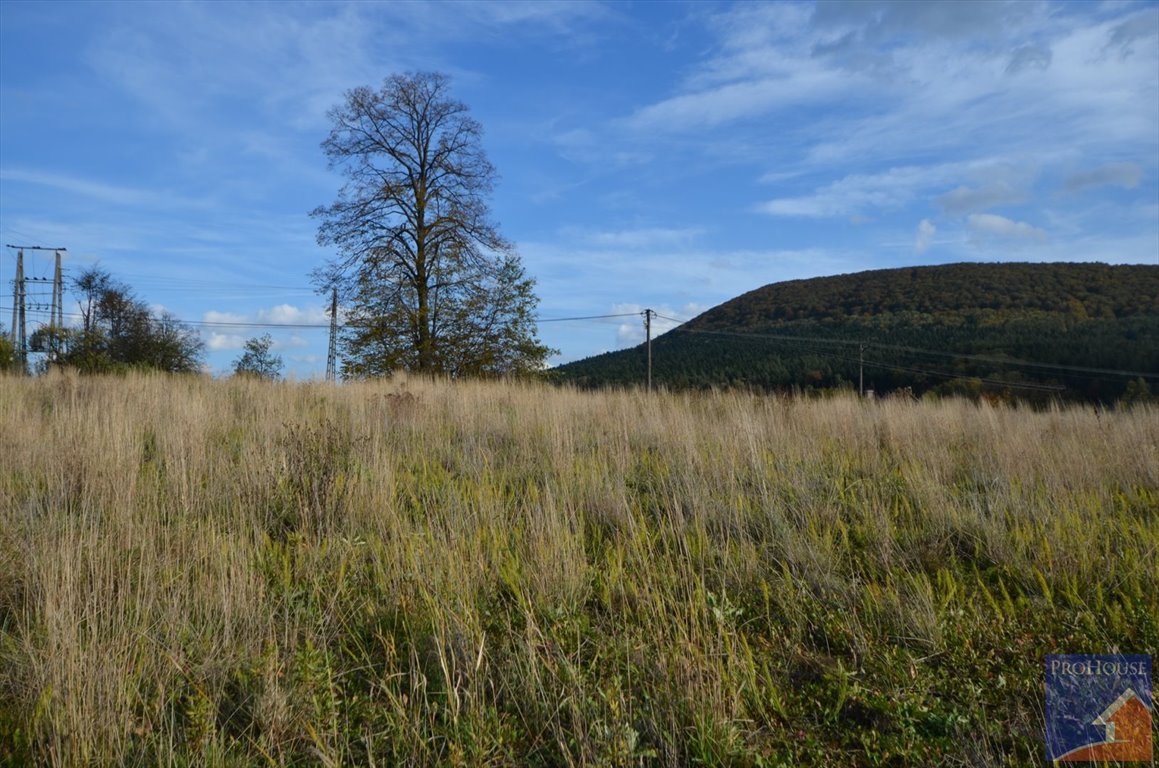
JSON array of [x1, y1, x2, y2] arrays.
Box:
[[628, 2, 1159, 195]]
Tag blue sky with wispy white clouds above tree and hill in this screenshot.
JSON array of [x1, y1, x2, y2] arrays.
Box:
[[0, 0, 1159, 379]]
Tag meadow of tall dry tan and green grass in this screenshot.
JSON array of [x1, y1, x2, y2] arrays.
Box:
[[0, 375, 1159, 767]]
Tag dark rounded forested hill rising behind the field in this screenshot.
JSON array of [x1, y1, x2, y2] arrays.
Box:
[[555, 263, 1159, 402]]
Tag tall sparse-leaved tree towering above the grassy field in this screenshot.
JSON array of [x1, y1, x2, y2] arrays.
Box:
[[313, 73, 551, 376]]
